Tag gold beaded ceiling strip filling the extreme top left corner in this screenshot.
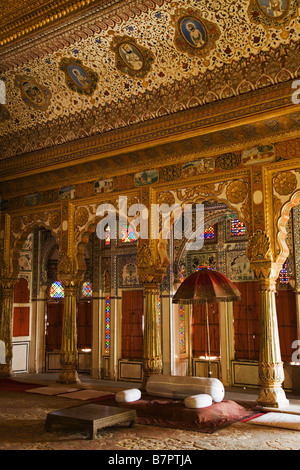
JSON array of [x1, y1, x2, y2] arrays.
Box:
[[0, 0, 106, 46]]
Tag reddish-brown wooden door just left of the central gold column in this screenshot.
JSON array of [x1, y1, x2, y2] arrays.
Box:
[[122, 290, 144, 359]]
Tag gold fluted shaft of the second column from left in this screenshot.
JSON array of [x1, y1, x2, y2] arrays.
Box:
[[58, 280, 80, 384]]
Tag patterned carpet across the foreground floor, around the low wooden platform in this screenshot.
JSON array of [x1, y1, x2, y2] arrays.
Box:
[[0, 391, 300, 452]]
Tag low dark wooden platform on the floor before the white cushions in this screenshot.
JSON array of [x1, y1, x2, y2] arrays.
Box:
[[45, 403, 137, 439]]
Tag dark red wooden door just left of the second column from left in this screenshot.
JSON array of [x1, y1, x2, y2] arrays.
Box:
[[45, 302, 64, 351]]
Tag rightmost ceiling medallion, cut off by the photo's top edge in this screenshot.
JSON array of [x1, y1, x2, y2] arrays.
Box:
[[248, 0, 300, 27]]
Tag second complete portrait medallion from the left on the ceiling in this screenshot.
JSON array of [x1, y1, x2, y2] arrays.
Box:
[[59, 58, 99, 96]]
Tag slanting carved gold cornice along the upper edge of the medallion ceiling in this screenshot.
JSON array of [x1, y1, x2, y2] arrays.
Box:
[[0, 0, 170, 72]]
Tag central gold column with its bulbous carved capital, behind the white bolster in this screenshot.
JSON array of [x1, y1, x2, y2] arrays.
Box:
[[137, 244, 165, 389]]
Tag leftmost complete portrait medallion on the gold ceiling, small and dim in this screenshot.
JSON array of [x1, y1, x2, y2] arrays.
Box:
[[16, 76, 51, 111]]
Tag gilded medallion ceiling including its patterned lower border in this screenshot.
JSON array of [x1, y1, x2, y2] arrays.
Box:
[[0, 0, 300, 163]]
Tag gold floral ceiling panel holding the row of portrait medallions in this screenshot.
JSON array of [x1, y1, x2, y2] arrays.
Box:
[[0, 0, 300, 147]]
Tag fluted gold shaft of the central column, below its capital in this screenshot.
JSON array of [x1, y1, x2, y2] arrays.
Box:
[[142, 284, 162, 388]]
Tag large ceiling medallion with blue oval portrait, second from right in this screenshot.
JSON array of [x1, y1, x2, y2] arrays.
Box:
[[172, 10, 221, 57]]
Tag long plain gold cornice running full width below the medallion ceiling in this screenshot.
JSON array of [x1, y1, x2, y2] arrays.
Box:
[[0, 78, 300, 181]]
